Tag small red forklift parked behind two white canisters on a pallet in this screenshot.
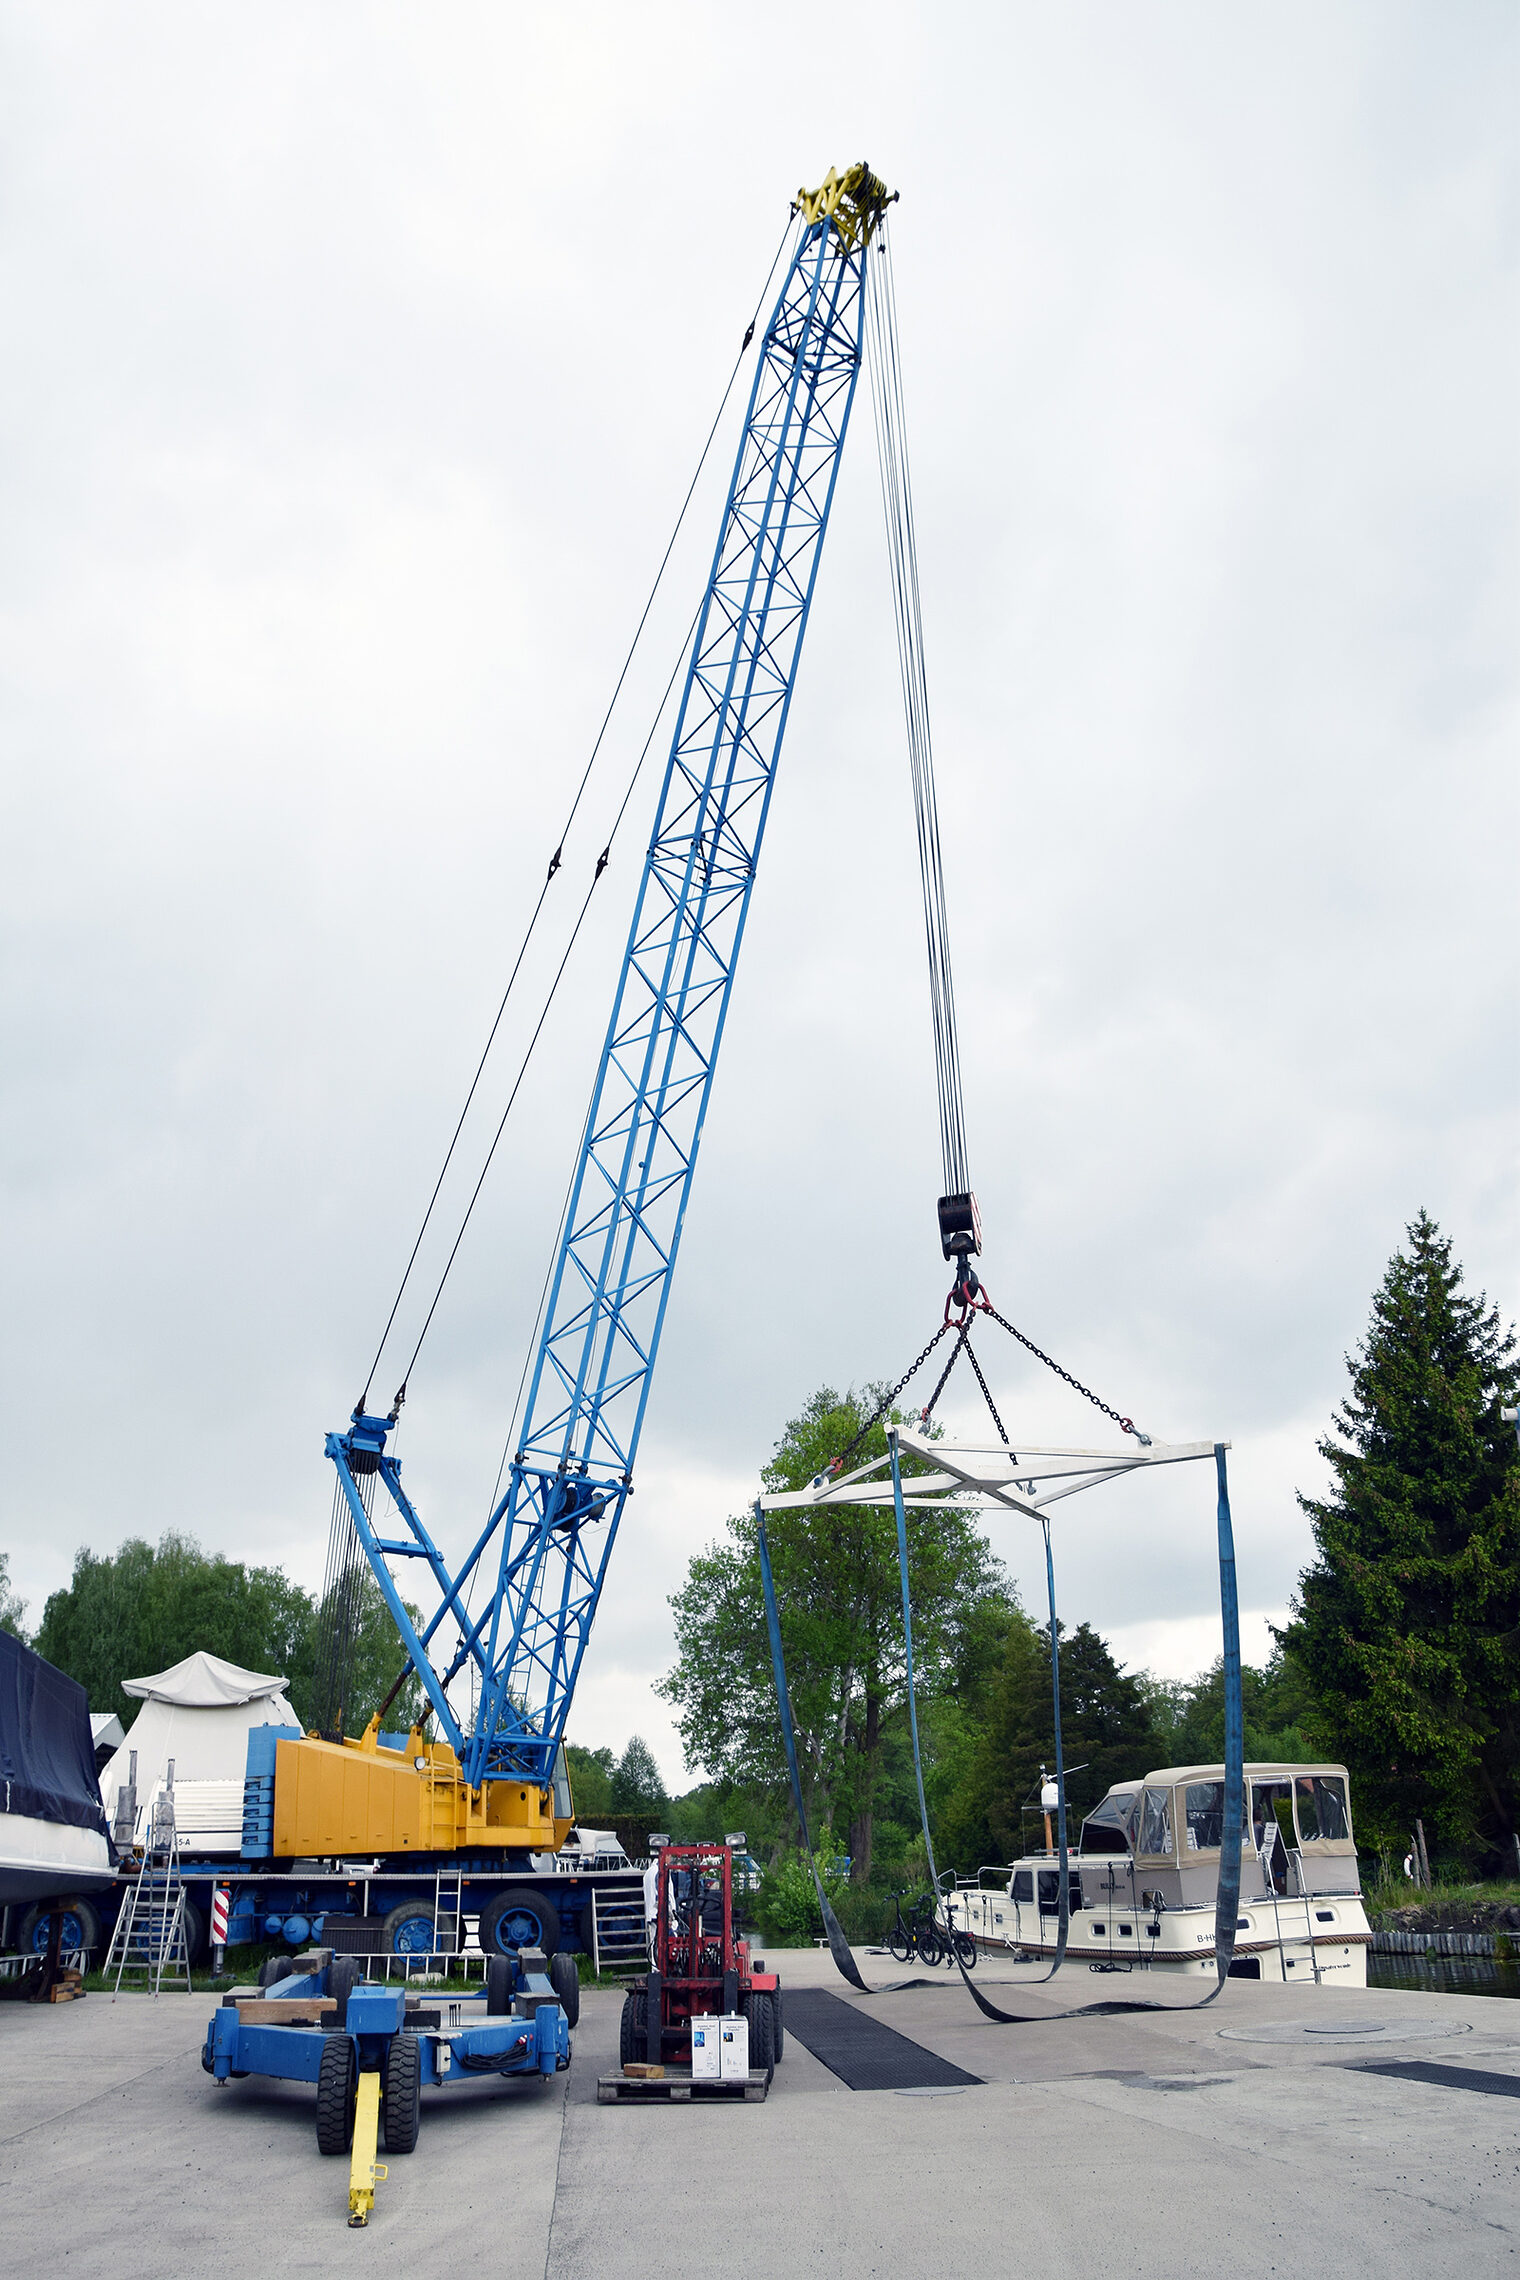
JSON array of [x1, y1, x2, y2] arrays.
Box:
[[599, 1838, 784, 2098]]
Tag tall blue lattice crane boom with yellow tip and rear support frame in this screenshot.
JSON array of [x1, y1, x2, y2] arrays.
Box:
[[276, 166, 889, 1851]]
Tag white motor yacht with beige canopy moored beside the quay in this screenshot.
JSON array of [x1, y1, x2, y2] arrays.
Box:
[[946, 1765, 1372, 1988]]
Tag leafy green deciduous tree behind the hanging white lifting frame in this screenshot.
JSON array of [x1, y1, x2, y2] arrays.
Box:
[[661, 1386, 1014, 1881]]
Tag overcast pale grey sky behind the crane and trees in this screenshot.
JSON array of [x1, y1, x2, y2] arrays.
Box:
[[0, 0, 1520, 1785]]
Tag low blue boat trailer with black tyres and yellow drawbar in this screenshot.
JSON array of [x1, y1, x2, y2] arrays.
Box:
[[201, 1947, 579, 2225]]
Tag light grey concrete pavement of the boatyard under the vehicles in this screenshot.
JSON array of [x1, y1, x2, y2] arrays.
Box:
[[0, 1952, 1520, 2280]]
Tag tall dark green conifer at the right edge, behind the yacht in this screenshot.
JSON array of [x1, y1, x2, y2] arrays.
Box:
[[1283, 1211, 1520, 1854]]
